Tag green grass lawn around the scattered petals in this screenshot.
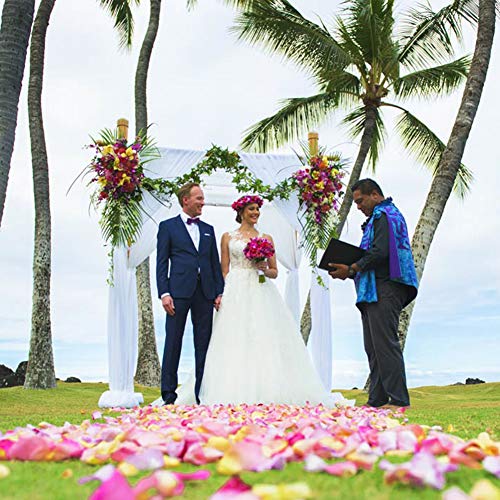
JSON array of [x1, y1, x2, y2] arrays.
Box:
[[0, 382, 500, 500]]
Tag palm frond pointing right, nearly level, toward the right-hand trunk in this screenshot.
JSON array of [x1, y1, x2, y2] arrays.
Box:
[[394, 56, 471, 99]]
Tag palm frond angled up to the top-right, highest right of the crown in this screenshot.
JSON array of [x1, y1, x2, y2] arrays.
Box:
[[399, 0, 478, 69]]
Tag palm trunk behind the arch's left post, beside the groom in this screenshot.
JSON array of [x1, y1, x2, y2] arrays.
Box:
[[135, 0, 161, 387]]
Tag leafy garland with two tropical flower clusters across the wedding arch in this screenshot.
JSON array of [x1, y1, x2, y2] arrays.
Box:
[[82, 130, 345, 281]]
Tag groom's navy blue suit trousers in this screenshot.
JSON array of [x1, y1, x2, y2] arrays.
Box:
[[161, 281, 214, 403]]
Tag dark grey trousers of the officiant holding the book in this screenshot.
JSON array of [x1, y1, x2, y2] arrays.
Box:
[[357, 280, 410, 406]]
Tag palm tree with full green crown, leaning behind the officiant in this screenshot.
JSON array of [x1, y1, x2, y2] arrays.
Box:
[[234, 0, 476, 341]]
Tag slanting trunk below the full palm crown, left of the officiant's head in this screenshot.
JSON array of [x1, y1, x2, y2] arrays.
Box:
[[300, 103, 377, 344]]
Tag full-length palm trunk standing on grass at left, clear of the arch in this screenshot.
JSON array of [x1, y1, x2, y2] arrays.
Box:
[[24, 0, 56, 389]]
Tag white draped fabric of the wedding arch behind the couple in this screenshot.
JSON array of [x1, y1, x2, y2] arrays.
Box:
[[94, 120, 340, 407]]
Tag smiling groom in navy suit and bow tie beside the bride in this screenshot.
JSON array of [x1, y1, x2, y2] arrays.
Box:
[[156, 182, 224, 404]]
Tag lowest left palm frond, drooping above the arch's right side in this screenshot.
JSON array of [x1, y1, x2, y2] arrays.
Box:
[[241, 92, 339, 152]]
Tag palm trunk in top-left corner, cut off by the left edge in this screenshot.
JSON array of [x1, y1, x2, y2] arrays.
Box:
[[0, 0, 35, 226]]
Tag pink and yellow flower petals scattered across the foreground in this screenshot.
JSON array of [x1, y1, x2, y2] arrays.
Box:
[[0, 405, 500, 500]]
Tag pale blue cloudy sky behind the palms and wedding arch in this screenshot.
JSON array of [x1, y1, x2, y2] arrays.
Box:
[[0, 0, 500, 388]]
